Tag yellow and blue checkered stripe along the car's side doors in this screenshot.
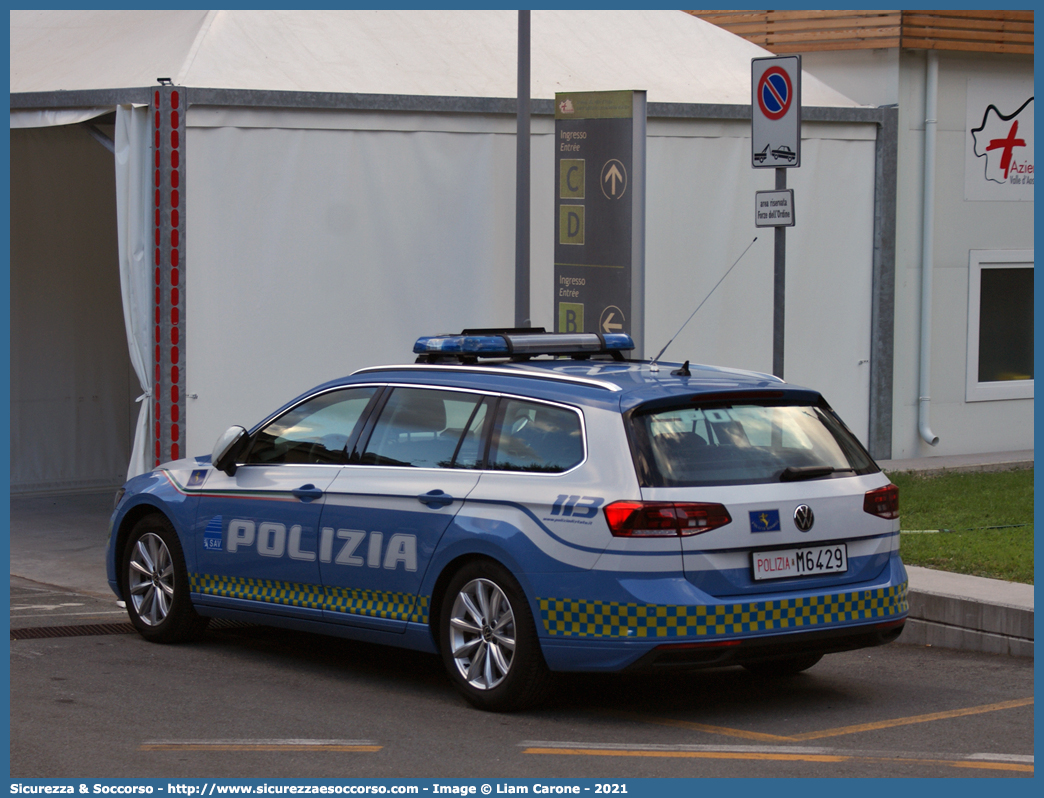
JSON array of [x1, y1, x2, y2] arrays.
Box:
[[190, 573, 430, 624]]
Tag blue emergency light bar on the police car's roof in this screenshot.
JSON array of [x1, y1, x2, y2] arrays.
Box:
[[413, 332, 635, 357]]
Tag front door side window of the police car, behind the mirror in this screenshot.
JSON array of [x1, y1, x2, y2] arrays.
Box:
[[243, 386, 377, 465]]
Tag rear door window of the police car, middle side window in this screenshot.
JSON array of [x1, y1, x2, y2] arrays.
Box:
[[358, 388, 487, 468]]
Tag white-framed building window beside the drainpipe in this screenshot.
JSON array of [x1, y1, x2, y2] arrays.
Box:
[[965, 250, 1034, 402]]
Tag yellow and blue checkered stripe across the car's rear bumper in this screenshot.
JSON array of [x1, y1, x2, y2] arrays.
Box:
[[539, 582, 909, 638]]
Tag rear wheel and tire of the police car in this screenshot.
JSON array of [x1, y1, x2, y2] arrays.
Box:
[[438, 560, 552, 712]]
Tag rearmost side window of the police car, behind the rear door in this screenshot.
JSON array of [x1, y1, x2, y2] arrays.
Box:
[[490, 399, 584, 473]]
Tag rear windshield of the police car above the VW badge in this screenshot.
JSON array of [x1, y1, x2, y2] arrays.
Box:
[[631, 402, 878, 487]]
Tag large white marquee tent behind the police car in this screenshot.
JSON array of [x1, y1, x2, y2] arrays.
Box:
[[10, 10, 891, 492]]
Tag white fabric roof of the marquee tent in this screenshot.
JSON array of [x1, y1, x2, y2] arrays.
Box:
[[10, 10, 855, 107]]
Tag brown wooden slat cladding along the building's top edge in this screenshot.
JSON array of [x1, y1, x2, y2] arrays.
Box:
[[688, 10, 1034, 55]]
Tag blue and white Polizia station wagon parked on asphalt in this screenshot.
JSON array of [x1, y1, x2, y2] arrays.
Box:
[[108, 330, 908, 710]]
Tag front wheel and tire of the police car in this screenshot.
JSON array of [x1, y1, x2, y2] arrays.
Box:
[[123, 515, 210, 642]]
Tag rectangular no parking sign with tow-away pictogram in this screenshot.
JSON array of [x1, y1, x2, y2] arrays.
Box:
[[751, 55, 801, 168]]
